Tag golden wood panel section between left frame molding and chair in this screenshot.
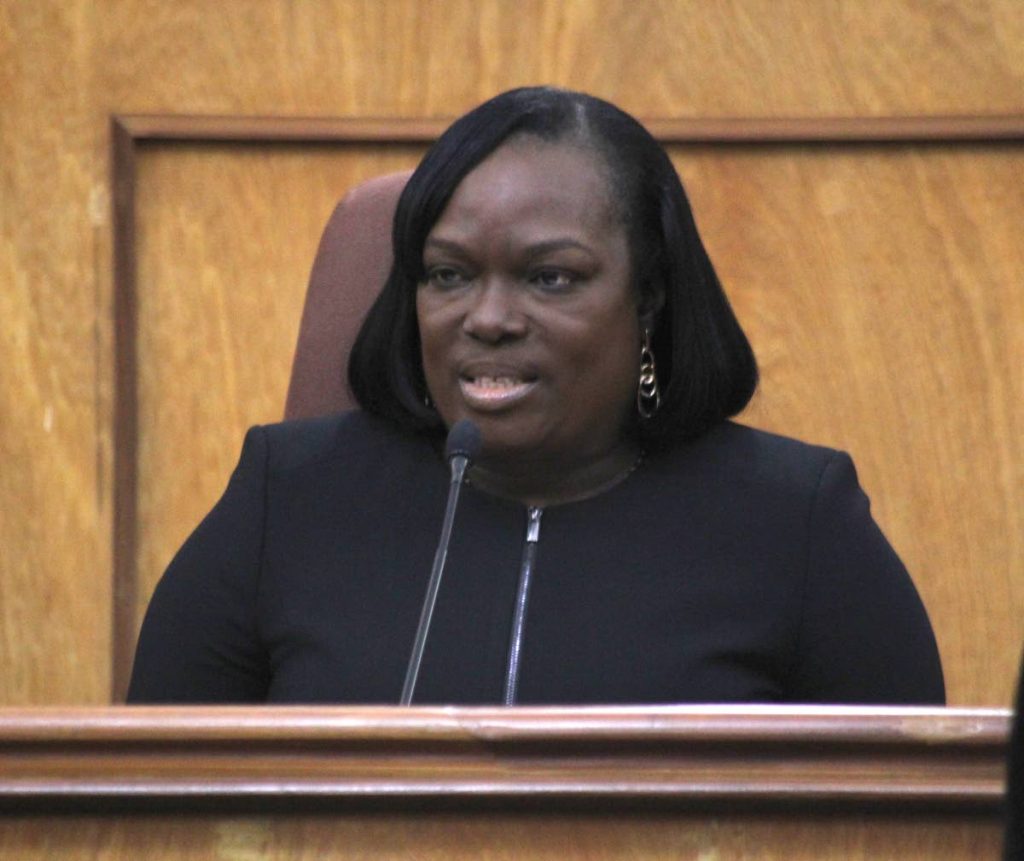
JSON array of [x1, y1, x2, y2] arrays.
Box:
[[136, 144, 422, 634]]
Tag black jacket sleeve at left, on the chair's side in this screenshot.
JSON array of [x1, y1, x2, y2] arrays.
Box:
[[128, 428, 268, 703]]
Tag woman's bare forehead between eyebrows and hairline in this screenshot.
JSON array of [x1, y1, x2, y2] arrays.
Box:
[[431, 136, 620, 235]]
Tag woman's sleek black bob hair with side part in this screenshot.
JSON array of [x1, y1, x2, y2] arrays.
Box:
[[348, 87, 758, 446]]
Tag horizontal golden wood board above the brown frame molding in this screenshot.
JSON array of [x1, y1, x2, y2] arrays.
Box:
[[90, 0, 1024, 117]]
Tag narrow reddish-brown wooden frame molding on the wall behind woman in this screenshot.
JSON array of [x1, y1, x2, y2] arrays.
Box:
[[111, 115, 1024, 701]]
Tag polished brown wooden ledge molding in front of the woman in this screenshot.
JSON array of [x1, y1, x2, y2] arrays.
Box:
[[0, 706, 1010, 814]]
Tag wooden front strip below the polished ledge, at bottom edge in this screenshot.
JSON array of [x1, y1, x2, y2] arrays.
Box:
[[0, 810, 1001, 861]]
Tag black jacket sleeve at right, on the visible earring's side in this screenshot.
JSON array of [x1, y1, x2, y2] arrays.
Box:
[[791, 451, 945, 705]]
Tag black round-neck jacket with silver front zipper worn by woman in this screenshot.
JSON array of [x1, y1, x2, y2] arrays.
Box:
[[129, 413, 944, 703]]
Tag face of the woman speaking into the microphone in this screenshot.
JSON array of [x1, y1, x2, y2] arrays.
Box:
[[417, 137, 640, 463]]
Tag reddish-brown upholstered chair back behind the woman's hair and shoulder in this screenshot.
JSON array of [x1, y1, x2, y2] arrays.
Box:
[[285, 171, 411, 419]]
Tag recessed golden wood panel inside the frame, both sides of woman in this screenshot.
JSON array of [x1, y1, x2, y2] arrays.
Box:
[[128, 143, 1024, 704]]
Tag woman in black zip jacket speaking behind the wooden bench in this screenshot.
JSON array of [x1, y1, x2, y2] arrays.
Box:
[[129, 88, 944, 703]]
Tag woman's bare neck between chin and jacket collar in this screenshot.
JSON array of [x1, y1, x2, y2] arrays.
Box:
[[469, 441, 640, 508]]
